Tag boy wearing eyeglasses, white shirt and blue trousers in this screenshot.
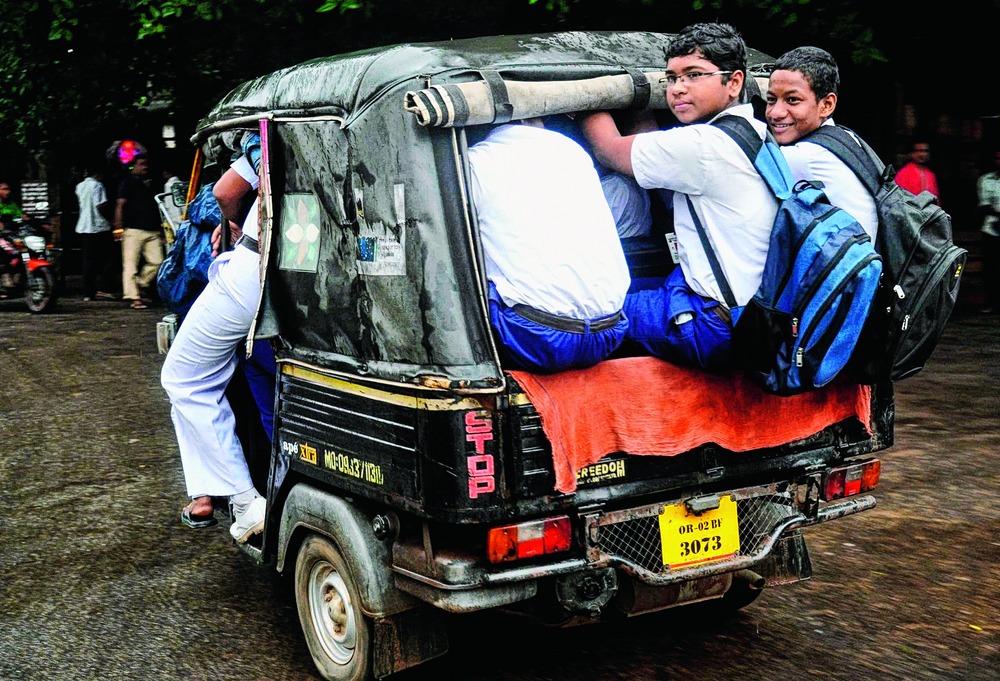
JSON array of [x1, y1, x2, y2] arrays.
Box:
[[582, 23, 777, 372]]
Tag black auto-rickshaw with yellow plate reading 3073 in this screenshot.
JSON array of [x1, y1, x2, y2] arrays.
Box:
[[176, 32, 893, 679]]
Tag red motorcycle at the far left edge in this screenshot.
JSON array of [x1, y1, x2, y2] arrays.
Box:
[[0, 218, 59, 313]]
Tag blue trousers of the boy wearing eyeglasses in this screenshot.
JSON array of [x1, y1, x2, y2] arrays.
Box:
[[624, 267, 742, 373]]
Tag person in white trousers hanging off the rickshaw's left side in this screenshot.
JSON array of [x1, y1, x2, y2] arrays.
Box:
[[160, 133, 267, 544]]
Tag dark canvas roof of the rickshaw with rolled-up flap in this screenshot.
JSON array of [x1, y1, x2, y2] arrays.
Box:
[[193, 31, 773, 138]]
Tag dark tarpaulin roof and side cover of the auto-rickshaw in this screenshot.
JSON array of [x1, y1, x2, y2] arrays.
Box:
[[192, 32, 769, 392]]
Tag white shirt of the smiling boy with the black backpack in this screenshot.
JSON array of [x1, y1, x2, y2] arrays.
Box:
[[781, 118, 878, 242]]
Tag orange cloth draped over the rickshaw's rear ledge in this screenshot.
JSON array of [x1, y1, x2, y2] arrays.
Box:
[[510, 357, 871, 493]]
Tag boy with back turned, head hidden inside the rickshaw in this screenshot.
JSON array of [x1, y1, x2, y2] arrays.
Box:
[[469, 118, 629, 373]]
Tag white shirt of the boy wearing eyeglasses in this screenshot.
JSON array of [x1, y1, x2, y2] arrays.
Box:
[[632, 104, 778, 305]]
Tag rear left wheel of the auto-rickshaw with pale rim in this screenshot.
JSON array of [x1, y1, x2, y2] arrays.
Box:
[[295, 534, 373, 681]]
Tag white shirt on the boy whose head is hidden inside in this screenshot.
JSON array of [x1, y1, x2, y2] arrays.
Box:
[[469, 124, 631, 319]]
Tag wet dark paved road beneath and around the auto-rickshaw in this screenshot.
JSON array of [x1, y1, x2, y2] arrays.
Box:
[[0, 288, 1000, 681]]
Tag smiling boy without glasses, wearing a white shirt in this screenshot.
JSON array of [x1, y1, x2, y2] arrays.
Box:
[[765, 47, 878, 240]]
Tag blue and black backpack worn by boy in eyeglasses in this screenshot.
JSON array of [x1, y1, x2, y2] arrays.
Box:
[[704, 116, 882, 395]]
